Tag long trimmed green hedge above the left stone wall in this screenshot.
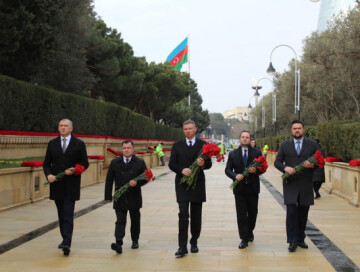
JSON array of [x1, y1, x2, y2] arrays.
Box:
[[0, 75, 183, 140]]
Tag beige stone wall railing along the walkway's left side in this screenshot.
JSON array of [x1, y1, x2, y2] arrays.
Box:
[[0, 135, 173, 211]]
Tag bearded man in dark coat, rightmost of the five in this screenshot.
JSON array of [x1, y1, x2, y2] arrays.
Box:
[[275, 120, 319, 252]]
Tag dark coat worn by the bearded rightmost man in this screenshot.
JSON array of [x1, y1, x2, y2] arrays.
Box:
[[274, 138, 319, 206]]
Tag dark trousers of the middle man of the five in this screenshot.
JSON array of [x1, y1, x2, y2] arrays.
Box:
[[178, 201, 202, 248]]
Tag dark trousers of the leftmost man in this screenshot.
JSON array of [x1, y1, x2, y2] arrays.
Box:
[[55, 193, 75, 247]]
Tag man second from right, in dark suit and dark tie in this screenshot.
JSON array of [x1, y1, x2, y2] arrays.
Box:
[[225, 131, 261, 248]]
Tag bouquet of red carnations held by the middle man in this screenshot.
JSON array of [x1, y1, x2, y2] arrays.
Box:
[[180, 143, 220, 190]]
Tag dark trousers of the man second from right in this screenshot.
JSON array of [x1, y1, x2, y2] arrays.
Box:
[[235, 194, 259, 241]]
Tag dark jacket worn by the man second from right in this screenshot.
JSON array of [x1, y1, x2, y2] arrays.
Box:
[[225, 146, 261, 194]]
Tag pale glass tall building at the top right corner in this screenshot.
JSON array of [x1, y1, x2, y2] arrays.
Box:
[[318, 0, 356, 32]]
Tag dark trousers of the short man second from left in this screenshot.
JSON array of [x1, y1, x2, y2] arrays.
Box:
[[115, 209, 140, 245]]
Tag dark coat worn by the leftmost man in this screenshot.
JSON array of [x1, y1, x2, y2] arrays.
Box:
[[43, 135, 89, 200]]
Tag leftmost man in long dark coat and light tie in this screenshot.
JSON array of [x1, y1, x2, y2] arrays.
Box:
[[43, 119, 89, 256]]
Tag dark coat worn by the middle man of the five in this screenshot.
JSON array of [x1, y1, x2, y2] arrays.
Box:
[[169, 138, 212, 202]]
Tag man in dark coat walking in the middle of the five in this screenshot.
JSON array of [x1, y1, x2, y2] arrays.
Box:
[[169, 120, 212, 257]]
